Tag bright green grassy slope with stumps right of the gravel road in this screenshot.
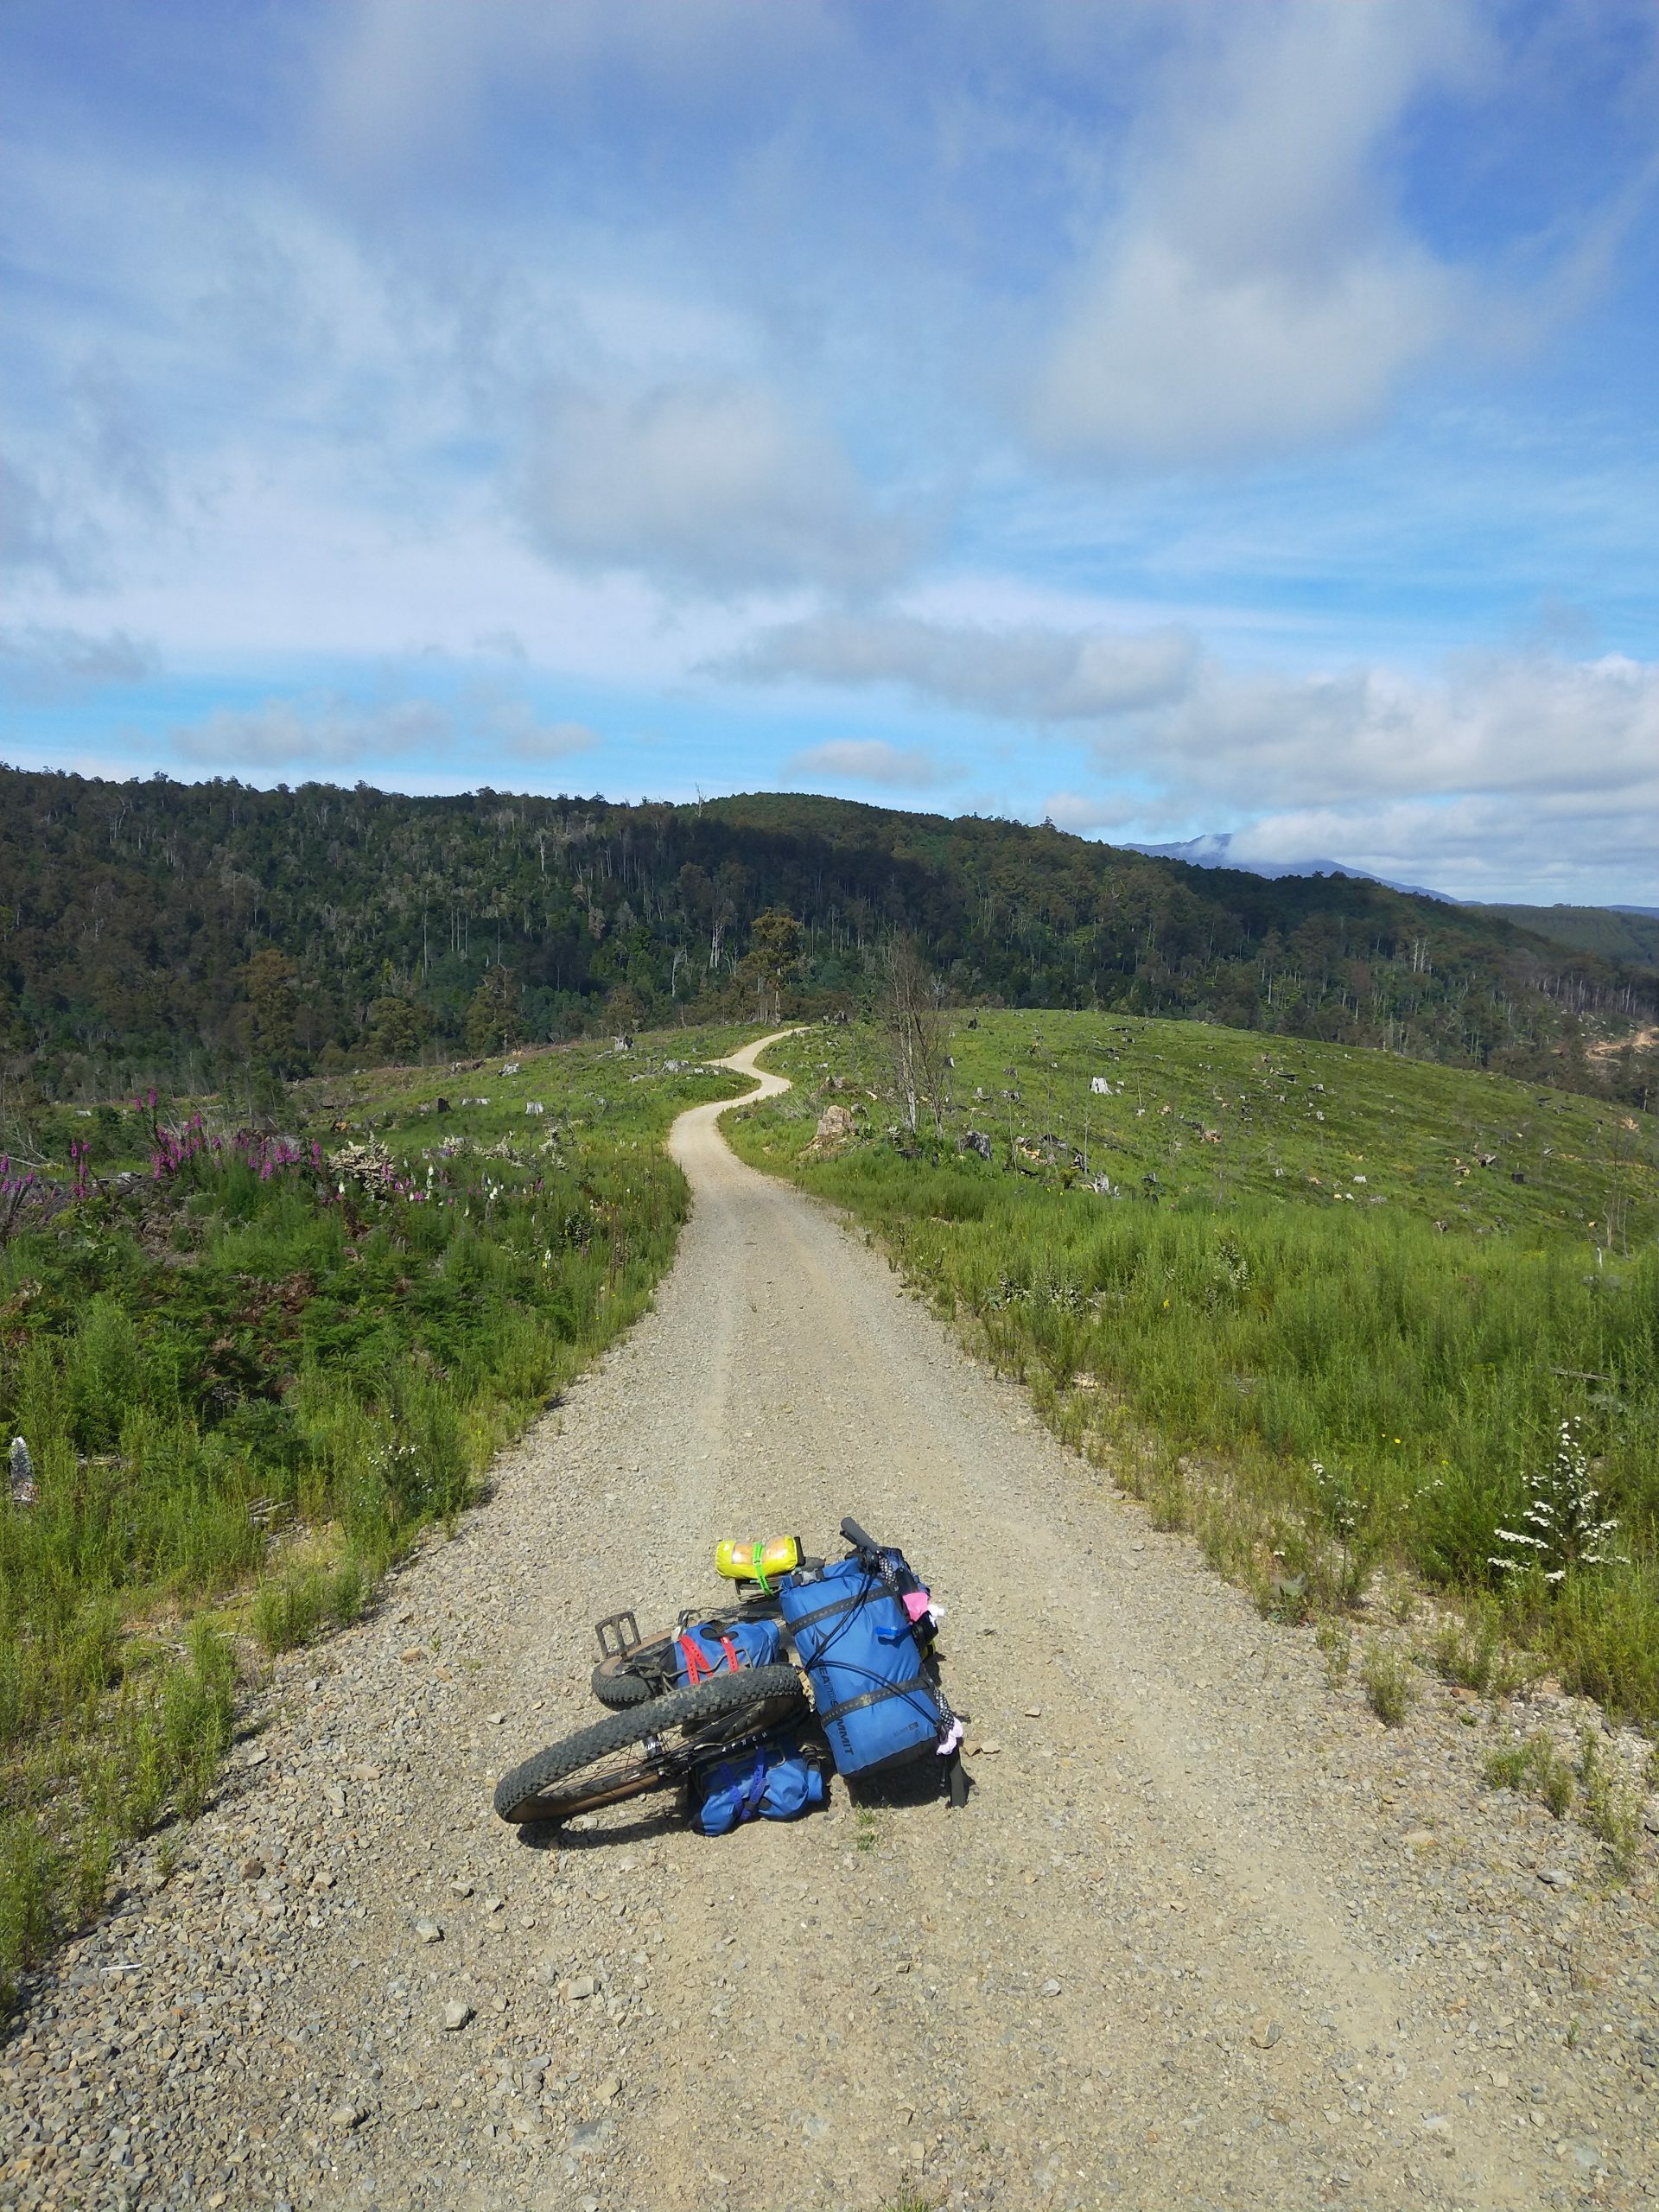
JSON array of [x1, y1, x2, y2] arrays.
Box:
[[728, 1013, 1659, 1726]]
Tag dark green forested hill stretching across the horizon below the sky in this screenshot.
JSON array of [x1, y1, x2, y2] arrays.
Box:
[[0, 770, 1655, 1097]]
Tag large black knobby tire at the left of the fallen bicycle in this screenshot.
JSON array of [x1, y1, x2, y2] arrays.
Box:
[[495, 1666, 805, 1821]]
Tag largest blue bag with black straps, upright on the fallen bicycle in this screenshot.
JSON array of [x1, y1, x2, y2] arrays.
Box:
[[779, 1557, 943, 1774]]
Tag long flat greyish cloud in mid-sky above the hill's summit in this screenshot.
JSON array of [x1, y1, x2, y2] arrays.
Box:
[[719, 613, 1199, 721]]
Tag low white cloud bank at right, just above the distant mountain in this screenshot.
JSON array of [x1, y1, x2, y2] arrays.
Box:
[[1051, 655, 1659, 902]]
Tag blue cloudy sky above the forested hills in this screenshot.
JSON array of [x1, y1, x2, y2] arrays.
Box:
[[0, 0, 1659, 905]]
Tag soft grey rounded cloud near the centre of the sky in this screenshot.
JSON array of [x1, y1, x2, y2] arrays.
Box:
[[518, 380, 916, 593]]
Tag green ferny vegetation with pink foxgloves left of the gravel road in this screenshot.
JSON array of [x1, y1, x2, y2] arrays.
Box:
[[0, 1031, 743, 2017]]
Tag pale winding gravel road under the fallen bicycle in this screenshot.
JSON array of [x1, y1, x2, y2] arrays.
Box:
[[0, 1046, 1659, 2212]]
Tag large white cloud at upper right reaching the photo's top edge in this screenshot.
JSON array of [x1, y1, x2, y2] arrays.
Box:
[[1028, 0, 1478, 465]]
